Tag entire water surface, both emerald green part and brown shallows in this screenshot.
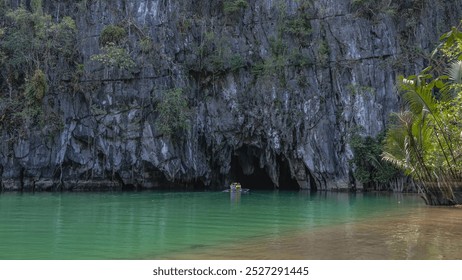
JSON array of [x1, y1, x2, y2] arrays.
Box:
[[0, 192, 462, 260]]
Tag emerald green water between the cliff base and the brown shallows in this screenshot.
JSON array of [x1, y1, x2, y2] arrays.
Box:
[[0, 192, 462, 260]]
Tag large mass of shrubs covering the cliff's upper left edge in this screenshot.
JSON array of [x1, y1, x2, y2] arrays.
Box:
[[0, 0, 77, 136]]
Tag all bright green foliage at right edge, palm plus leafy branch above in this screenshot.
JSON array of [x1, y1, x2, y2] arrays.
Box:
[[383, 22, 462, 204]]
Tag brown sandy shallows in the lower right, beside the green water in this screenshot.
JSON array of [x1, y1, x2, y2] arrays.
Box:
[[162, 207, 462, 260]]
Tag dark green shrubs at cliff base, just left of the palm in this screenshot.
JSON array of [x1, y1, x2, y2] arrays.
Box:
[[350, 133, 402, 189]]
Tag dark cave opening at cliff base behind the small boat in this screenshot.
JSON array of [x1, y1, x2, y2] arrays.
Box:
[[230, 147, 300, 190]]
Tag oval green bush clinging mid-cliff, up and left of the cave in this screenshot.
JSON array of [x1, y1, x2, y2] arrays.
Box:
[[156, 88, 189, 136]]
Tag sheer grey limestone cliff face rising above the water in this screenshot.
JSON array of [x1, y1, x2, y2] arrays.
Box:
[[0, 0, 462, 189]]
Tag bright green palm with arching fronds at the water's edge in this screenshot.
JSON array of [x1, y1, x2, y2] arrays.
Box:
[[382, 69, 462, 205]]
